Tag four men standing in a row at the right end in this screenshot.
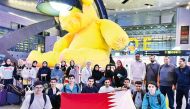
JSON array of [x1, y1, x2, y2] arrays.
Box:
[[130, 54, 190, 109]]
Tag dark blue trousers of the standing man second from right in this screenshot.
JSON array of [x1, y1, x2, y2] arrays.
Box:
[[160, 86, 174, 109]]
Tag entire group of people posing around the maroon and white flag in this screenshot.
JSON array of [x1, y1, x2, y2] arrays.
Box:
[[0, 53, 190, 109]]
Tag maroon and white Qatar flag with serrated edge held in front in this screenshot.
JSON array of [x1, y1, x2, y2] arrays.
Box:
[[61, 91, 136, 109]]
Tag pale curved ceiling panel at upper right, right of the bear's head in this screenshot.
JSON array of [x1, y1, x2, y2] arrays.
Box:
[[103, 0, 190, 12]]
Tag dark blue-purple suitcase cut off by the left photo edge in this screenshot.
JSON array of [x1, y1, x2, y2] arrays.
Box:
[[0, 89, 7, 106]]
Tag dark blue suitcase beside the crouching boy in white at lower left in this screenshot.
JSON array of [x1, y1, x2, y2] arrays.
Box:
[[7, 92, 22, 105]]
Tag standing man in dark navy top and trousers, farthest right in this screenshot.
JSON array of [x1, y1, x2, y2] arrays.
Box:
[[175, 58, 190, 109]]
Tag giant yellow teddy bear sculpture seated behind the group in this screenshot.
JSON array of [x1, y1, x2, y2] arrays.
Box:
[[27, 0, 129, 67]]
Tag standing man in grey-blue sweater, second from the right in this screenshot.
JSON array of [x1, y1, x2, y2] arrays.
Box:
[[157, 56, 176, 109]]
